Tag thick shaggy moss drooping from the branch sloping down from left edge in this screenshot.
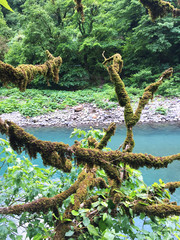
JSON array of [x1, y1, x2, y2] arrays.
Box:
[[2, 121, 72, 172]]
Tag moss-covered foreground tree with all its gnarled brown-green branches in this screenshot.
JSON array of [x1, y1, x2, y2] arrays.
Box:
[[0, 2, 180, 239]]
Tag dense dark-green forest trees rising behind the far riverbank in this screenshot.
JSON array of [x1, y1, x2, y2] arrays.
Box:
[[0, 0, 180, 90]]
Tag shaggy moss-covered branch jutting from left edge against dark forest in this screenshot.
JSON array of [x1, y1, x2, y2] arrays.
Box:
[[0, 50, 62, 91]]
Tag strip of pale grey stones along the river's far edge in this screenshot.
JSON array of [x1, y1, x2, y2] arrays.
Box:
[[0, 96, 180, 127]]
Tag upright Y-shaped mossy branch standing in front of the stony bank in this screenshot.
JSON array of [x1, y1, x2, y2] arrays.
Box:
[[103, 53, 173, 152]]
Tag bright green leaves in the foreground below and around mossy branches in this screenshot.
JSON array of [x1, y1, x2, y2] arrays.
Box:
[[0, 128, 180, 240]]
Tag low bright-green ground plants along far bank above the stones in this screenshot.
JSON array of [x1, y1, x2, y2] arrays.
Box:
[[0, 84, 142, 117]]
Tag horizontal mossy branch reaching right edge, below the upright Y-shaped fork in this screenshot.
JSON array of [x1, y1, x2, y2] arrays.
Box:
[[74, 148, 180, 170]]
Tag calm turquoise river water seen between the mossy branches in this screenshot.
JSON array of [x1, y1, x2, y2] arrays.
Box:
[[0, 124, 180, 203]]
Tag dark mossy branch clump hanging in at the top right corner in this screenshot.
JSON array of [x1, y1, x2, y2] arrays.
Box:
[[140, 0, 174, 21]]
